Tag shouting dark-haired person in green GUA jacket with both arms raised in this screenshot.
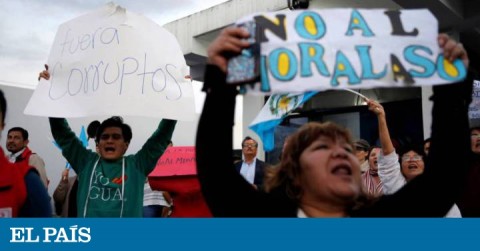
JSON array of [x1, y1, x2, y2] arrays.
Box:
[[39, 67, 176, 217]]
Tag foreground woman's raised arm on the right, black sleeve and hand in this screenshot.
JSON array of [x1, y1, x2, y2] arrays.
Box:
[[357, 35, 473, 217]]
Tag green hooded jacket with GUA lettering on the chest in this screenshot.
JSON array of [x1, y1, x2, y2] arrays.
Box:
[[50, 118, 177, 217]]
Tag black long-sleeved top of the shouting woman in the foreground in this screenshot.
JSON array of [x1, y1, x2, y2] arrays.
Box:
[[196, 65, 472, 217]]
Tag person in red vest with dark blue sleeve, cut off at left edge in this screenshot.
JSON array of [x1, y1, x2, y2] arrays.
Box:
[[0, 90, 52, 218]]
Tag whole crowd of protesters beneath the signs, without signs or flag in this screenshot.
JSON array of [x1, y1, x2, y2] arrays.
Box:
[[0, 15, 480, 217]]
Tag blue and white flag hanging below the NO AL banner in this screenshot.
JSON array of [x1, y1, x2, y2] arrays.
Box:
[[248, 91, 318, 152]]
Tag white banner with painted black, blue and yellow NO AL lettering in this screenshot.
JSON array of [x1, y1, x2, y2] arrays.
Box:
[[238, 9, 466, 93]]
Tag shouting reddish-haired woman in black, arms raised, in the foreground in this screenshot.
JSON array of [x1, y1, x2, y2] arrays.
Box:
[[196, 27, 472, 217]]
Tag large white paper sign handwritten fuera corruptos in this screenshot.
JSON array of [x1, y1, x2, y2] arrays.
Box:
[[25, 3, 195, 120]]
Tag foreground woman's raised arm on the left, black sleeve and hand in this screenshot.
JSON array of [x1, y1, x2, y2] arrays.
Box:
[[196, 27, 270, 217]]
